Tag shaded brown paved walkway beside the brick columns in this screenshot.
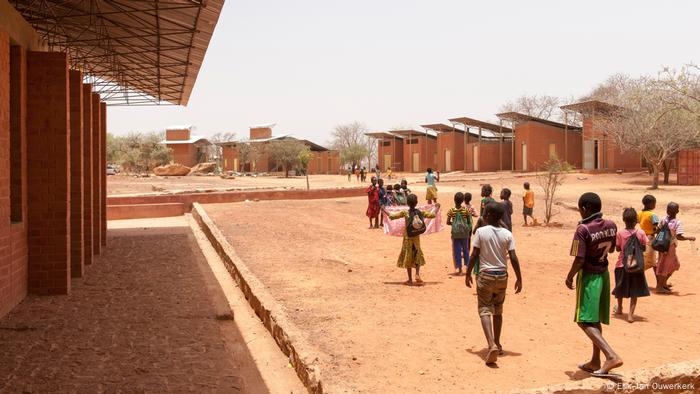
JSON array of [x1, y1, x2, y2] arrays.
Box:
[[0, 222, 243, 393]]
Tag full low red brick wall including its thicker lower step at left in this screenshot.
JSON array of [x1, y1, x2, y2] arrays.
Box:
[[107, 188, 365, 220]]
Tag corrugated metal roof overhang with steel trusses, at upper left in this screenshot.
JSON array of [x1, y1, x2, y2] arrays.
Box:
[[10, 0, 224, 105]]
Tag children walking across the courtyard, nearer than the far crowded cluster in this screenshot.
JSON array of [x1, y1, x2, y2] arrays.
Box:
[[370, 173, 695, 377]]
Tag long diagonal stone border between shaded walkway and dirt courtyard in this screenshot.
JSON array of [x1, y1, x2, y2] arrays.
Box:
[[192, 202, 323, 394]]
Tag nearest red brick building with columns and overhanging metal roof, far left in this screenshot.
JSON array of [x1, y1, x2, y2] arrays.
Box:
[[0, 0, 223, 317]]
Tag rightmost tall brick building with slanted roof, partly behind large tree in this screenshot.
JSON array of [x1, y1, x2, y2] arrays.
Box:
[[560, 100, 644, 172]]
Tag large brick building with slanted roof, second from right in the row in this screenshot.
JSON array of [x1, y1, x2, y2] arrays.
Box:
[[497, 112, 582, 171]]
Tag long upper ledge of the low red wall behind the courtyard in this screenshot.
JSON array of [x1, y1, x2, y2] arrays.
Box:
[[107, 188, 365, 210]]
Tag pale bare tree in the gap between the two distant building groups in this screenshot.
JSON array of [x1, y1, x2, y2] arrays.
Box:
[[331, 122, 377, 165]]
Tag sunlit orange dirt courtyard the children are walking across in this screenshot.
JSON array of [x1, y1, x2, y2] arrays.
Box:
[[205, 174, 700, 393]]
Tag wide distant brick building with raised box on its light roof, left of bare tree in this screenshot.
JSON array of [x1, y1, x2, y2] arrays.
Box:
[[217, 124, 341, 175]]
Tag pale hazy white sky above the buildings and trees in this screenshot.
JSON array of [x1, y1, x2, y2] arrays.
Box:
[[108, 0, 700, 143]]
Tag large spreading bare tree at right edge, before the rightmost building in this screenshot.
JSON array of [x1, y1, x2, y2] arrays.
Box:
[[592, 74, 700, 189]]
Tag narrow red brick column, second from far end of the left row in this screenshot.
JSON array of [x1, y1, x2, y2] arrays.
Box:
[[92, 93, 104, 255]]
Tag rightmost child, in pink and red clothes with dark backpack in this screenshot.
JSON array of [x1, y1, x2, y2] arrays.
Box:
[[656, 202, 695, 294]]
